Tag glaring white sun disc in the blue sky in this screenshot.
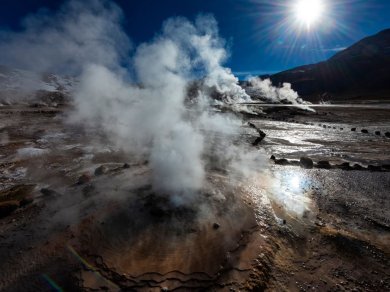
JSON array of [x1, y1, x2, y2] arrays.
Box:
[[293, 0, 325, 29]]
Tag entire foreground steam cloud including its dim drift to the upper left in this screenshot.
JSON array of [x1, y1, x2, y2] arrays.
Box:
[[0, 0, 262, 203]]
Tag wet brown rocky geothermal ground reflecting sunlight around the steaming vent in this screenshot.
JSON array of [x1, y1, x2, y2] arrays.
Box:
[[0, 106, 390, 291]]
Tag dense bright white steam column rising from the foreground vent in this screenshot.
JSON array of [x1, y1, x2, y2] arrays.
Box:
[[72, 16, 262, 201]]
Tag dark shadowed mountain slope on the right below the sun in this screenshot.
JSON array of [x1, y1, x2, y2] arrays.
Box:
[[260, 29, 390, 101]]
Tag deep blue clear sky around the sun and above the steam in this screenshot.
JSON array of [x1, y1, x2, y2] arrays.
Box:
[[0, 0, 390, 78]]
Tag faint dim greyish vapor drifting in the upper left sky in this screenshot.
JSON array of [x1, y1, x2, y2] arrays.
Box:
[[0, 0, 130, 74]]
